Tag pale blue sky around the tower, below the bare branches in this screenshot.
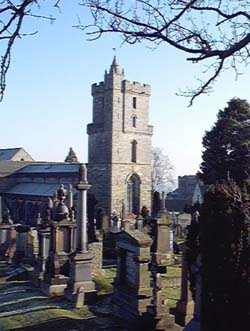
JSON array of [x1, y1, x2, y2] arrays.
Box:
[[0, 2, 250, 177]]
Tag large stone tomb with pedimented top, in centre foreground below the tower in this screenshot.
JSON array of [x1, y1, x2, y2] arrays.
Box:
[[113, 230, 152, 321]]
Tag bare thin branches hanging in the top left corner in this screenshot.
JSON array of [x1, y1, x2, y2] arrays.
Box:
[[0, 0, 61, 101]]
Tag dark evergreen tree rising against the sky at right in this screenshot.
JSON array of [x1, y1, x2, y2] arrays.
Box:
[[199, 98, 250, 184]]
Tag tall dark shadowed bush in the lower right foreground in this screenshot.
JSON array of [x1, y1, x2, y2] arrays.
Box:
[[199, 182, 250, 331]]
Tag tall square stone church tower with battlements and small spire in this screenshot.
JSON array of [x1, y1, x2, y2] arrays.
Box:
[[87, 57, 153, 215]]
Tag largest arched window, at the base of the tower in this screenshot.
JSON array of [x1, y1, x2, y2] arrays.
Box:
[[127, 173, 141, 215]]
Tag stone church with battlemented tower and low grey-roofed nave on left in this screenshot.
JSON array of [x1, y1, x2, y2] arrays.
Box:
[[0, 58, 153, 225]]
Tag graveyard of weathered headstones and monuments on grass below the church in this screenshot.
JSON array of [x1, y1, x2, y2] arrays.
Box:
[[0, 172, 186, 331]]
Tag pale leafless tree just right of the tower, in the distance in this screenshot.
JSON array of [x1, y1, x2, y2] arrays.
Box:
[[152, 147, 174, 192]]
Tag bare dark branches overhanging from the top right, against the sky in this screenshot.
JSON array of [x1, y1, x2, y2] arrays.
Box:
[[79, 0, 250, 105]]
